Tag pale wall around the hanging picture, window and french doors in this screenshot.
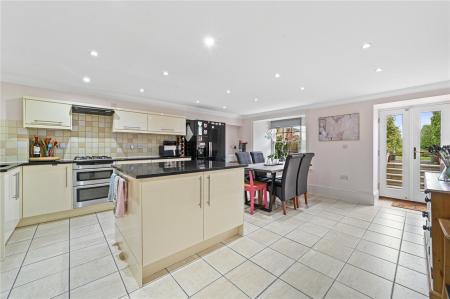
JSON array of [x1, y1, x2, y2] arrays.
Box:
[[243, 88, 450, 204]]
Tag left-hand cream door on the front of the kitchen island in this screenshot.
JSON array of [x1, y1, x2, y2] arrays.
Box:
[[141, 173, 204, 264]]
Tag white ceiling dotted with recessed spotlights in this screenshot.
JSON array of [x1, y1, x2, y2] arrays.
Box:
[[1, 1, 450, 115]]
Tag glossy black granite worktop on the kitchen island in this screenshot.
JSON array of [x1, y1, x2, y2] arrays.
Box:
[[113, 160, 247, 179]]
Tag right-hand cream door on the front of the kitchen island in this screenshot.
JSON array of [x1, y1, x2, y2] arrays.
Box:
[[203, 168, 244, 240]]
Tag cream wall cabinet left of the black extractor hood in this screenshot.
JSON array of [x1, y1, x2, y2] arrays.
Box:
[[23, 97, 72, 130]]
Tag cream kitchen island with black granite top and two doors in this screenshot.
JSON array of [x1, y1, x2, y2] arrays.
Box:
[[114, 161, 246, 286]]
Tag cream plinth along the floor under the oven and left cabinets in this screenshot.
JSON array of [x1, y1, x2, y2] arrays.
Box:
[[17, 202, 113, 227]]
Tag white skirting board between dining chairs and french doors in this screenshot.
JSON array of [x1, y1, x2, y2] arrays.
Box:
[[308, 185, 375, 205]]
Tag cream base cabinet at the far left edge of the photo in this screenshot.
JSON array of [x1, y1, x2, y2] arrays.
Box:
[[0, 167, 22, 257]]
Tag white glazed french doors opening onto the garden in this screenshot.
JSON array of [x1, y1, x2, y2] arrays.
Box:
[[380, 104, 450, 202]]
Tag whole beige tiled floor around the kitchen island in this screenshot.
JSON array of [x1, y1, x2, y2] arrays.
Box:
[[0, 197, 428, 298]]
